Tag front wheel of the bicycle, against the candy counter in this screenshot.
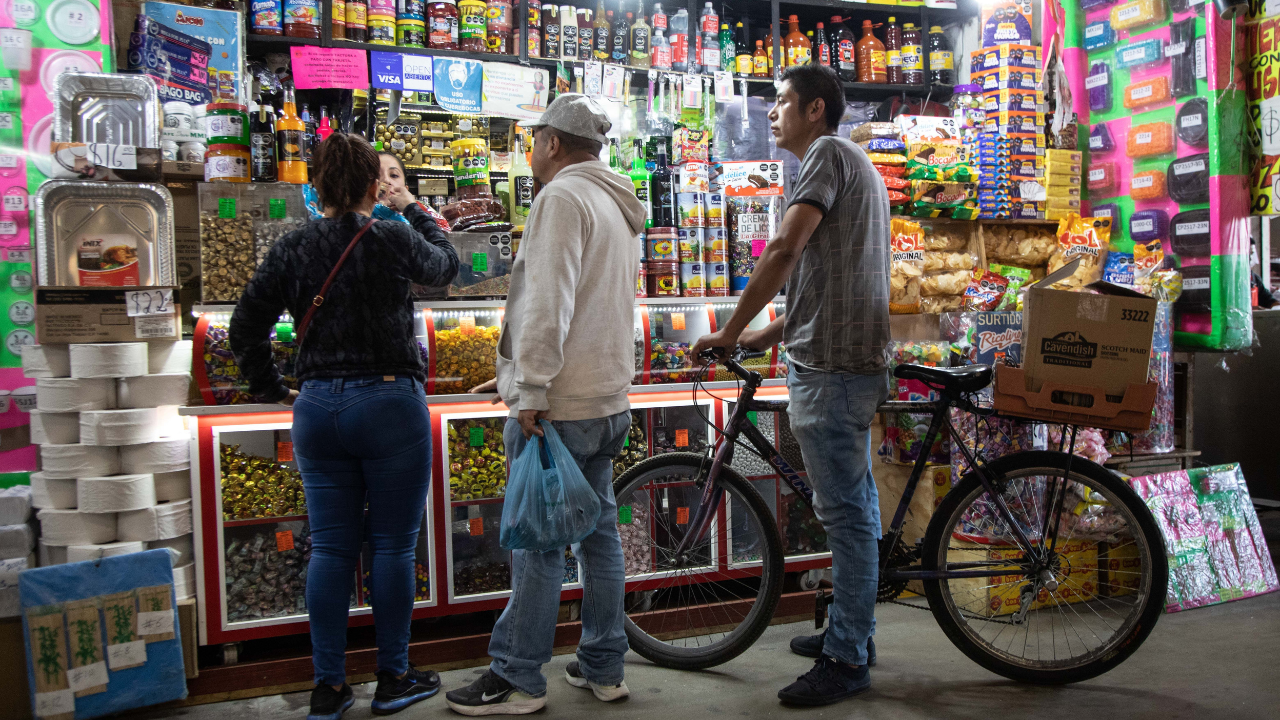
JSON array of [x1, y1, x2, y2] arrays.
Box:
[[613, 452, 783, 670]]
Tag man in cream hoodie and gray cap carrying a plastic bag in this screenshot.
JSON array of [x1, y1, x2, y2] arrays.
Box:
[[445, 94, 645, 716]]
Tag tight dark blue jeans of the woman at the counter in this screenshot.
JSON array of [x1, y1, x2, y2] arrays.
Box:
[[293, 377, 431, 685]]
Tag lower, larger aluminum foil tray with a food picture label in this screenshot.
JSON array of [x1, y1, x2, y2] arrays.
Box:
[[35, 181, 178, 287]]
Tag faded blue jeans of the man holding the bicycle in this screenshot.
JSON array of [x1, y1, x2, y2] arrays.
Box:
[[787, 363, 888, 665]]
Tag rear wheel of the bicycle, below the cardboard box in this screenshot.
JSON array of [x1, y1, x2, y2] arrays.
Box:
[[922, 451, 1169, 684]]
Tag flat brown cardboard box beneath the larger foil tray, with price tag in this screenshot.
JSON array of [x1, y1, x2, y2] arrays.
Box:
[[36, 287, 182, 342]]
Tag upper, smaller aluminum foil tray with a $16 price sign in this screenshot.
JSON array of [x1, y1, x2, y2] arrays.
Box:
[[54, 73, 161, 147]]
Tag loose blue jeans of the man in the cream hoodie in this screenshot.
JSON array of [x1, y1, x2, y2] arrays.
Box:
[[489, 413, 631, 697]]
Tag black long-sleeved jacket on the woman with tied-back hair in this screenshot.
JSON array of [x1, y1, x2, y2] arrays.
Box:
[[229, 205, 458, 402]]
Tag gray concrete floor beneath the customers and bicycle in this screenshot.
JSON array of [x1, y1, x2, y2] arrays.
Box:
[[136, 593, 1280, 720]]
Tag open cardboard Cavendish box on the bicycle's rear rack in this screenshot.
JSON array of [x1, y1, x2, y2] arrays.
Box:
[[995, 261, 1156, 432]]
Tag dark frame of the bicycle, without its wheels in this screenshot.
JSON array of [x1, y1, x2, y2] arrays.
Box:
[[675, 359, 1059, 580]]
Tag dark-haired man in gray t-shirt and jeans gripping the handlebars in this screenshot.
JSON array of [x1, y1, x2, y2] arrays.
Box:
[[694, 65, 890, 705]]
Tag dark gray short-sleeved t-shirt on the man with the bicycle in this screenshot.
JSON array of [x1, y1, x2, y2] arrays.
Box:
[[783, 136, 890, 375]]
